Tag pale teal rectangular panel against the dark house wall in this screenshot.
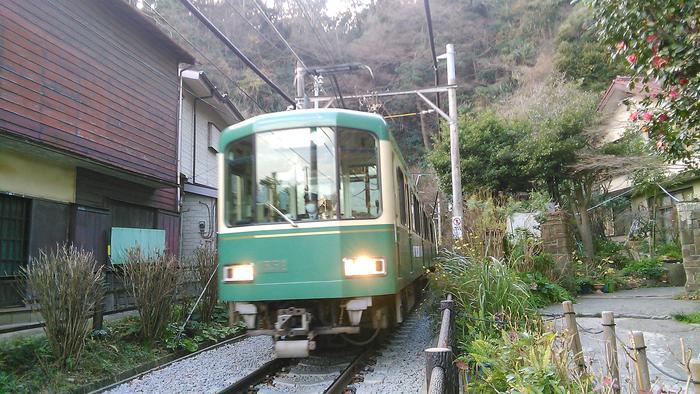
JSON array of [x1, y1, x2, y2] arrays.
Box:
[[110, 227, 165, 264]]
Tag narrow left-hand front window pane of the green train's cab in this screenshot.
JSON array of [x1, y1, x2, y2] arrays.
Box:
[[225, 136, 253, 226]]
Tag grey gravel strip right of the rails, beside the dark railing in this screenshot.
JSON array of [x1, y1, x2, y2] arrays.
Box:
[[353, 311, 435, 394]]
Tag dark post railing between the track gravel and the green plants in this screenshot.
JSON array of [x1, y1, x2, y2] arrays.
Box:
[[425, 294, 459, 394]]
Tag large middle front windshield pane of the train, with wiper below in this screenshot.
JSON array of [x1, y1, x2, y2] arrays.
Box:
[[255, 127, 338, 223]]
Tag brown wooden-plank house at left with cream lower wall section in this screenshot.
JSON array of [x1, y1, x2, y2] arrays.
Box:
[[0, 0, 194, 325]]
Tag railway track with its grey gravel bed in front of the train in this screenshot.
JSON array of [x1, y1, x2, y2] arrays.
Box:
[[95, 300, 431, 394]]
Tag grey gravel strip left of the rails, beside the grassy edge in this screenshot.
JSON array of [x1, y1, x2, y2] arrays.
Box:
[[108, 336, 275, 394]]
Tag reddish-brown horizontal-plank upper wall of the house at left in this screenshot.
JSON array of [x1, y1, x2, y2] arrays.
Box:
[[0, 0, 193, 182]]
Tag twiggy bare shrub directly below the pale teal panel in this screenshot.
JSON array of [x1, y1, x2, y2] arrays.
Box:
[[124, 247, 179, 339]]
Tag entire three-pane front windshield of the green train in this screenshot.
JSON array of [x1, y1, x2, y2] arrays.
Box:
[[225, 127, 381, 226]]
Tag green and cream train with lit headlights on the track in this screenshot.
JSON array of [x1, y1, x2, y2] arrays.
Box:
[[218, 109, 437, 357]]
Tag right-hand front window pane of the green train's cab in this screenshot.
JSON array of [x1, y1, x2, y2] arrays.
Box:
[[338, 128, 382, 219]]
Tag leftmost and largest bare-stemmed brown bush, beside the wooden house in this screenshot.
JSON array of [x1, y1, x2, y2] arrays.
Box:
[[23, 244, 104, 367]]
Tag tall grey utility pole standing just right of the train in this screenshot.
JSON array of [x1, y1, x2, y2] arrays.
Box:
[[446, 44, 463, 239]]
